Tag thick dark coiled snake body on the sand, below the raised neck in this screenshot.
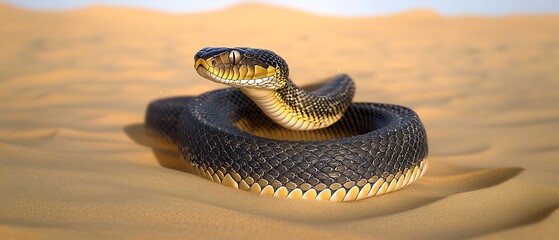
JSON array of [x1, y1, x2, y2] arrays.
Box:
[[146, 49, 428, 201]]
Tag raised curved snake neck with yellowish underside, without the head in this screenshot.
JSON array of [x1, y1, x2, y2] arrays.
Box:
[[241, 76, 355, 130]]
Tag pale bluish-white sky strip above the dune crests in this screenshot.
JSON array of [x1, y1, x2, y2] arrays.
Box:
[[0, 0, 559, 16]]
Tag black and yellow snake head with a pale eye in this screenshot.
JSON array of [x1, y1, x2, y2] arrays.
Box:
[[194, 47, 289, 89]]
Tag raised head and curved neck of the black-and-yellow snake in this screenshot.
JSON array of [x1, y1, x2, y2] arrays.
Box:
[[194, 48, 355, 130]]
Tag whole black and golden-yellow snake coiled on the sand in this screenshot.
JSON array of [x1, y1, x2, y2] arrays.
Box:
[[145, 47, 428, 202]]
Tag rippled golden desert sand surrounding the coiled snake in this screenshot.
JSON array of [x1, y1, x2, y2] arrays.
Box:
[[0, 2, 559, 239]]
